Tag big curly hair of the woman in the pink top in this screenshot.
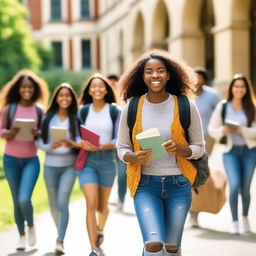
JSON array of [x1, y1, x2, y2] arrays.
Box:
[[0, 69, 49, 109]]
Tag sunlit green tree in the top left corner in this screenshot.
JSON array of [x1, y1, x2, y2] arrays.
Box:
[[0, 0, 41, 86]]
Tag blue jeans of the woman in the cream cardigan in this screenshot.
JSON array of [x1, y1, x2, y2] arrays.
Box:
[[223, 146, 256, 221]]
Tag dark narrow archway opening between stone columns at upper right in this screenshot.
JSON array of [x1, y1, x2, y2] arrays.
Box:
[[200, 0, 215, 83]]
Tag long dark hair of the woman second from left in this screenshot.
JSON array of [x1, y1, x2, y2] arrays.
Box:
[[41, 83, 78, 143]]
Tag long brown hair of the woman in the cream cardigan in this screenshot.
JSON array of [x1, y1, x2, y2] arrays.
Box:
[[227, 74, 256, 127]]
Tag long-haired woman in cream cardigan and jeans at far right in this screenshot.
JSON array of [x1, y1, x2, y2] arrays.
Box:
[[208, 74, 256, 234]]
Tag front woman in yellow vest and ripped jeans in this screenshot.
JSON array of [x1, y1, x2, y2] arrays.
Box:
[[117, 50, 205, 256]]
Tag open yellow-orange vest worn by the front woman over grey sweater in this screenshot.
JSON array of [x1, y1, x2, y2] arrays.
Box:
[[127, 95, 197, 197]]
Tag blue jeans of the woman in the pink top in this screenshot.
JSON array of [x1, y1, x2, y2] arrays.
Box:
[[3, 155, 40, 235]]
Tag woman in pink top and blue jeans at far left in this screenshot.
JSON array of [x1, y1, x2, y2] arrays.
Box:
[[0, 70, 48, 250]]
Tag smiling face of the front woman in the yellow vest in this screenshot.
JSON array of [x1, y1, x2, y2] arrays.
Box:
[[143, 59, 170, 93]]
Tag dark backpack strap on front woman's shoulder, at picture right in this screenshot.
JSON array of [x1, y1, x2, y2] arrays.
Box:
[[177, 95, 190, 142]]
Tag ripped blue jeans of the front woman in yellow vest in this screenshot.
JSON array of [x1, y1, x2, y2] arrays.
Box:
[[134, 175, 191, 255]]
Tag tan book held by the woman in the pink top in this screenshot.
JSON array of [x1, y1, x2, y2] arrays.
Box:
[[15, 118, 36, 141]]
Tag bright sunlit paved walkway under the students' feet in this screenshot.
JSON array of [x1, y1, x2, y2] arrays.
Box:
[[0, 147, 256, 256]]
